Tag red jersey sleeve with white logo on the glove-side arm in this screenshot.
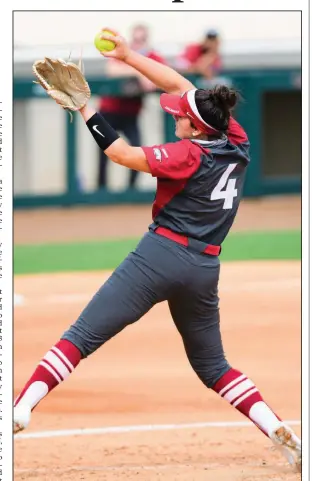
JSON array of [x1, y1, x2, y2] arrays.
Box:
[[142, 140, 201, 180]]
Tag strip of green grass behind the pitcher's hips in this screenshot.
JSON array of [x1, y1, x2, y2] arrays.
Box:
[[14, 231, 301, 274]]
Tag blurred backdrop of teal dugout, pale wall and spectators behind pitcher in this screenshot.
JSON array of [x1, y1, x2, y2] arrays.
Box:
[[14, 12, 301, 202]]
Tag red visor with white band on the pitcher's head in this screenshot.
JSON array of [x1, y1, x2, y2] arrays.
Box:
[[160, 90, 217, 134]]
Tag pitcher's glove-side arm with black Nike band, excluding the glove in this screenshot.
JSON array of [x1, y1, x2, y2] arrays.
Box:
[[80, 105, 151, 173]]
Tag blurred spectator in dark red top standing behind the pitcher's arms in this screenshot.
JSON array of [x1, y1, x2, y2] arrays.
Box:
[[98, 25, 165, 187]]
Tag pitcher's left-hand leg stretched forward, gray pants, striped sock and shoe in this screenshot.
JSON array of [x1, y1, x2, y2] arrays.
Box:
[[14, 234, 176, 432]]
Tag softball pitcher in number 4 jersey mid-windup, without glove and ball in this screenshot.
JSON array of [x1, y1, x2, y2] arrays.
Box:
[[14, 29, 301, 469]]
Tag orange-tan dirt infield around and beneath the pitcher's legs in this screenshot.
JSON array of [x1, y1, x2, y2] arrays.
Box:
[[14, 261, 301, 481]]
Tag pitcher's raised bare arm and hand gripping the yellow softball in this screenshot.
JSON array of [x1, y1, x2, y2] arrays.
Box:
[[101, 28, 195, 95]]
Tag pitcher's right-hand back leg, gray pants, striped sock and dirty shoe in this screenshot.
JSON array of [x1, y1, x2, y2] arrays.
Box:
[[169, 260, 301, 467]]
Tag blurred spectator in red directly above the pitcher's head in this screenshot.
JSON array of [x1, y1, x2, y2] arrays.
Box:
[[177, 29, 222, 80]]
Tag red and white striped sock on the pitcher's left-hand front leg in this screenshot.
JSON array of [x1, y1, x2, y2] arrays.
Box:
[[14, 340, 81, 409]]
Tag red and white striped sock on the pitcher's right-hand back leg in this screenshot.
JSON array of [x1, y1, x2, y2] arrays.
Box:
[[212, 369, 281, 436]]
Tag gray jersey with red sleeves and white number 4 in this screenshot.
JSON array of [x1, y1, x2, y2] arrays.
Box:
[[143, 119, 249, 245]]
